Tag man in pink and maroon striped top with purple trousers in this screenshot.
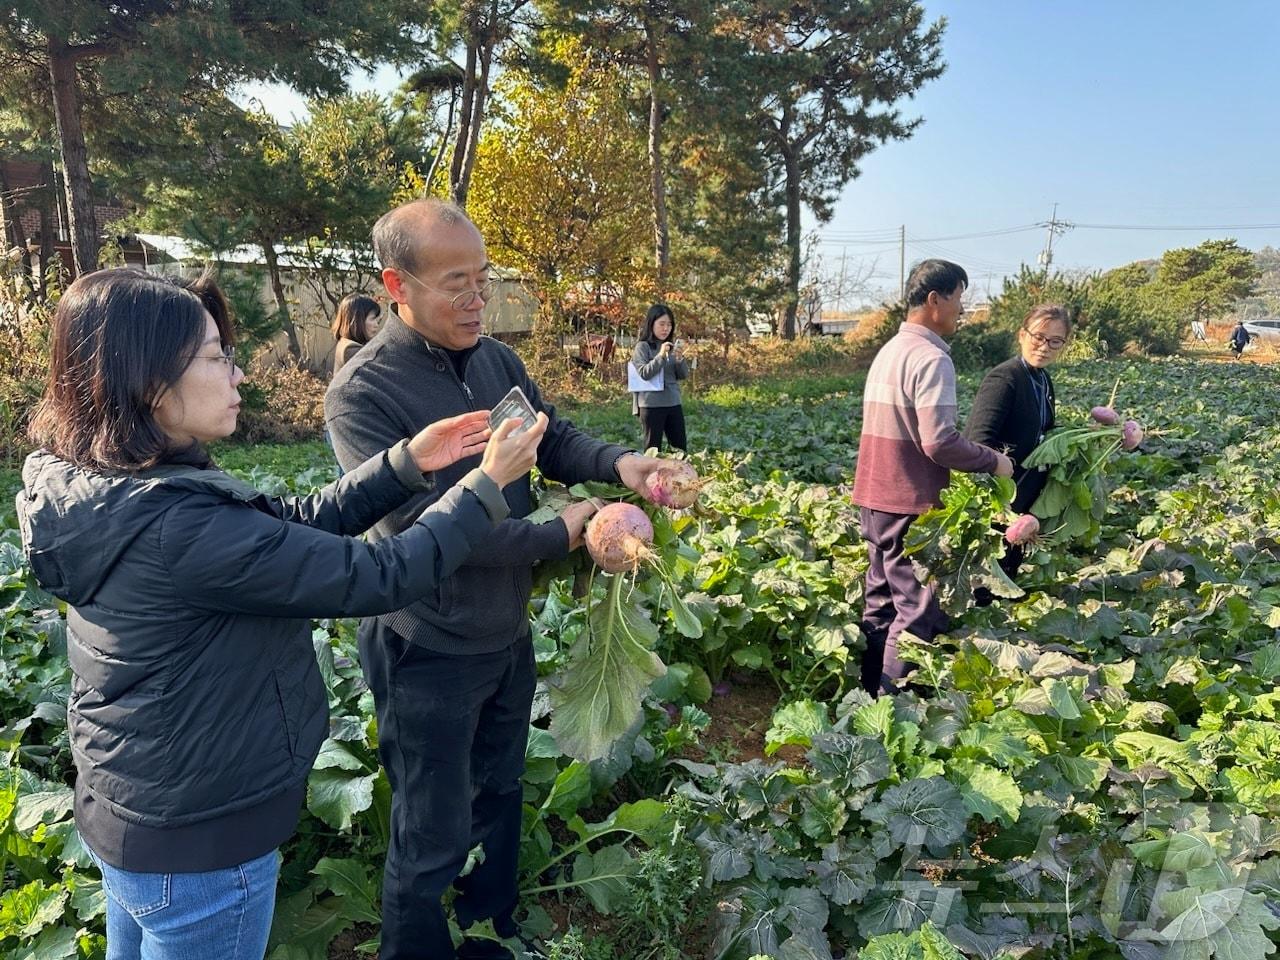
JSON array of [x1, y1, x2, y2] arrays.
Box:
[[854, 260, 1014, 695]]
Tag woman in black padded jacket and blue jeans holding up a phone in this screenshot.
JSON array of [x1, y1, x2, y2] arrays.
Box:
[[18, 270, 544, 960]]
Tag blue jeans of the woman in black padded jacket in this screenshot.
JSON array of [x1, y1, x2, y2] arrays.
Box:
[[93, 850, 280, 960]]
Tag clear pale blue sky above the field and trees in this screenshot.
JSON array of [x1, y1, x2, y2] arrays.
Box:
[[240, 0, 1280, 300]]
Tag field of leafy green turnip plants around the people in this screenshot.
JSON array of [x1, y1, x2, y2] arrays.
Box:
[[0, 360, 1280, 960]]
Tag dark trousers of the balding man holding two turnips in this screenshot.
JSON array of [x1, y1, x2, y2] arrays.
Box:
[[360, 620, 536, 960]]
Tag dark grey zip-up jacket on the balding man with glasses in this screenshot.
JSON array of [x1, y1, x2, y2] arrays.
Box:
[[325, 312, 628, 654]]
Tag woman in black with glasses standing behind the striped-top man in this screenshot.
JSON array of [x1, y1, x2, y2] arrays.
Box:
[[964, 303, 1071, 576]]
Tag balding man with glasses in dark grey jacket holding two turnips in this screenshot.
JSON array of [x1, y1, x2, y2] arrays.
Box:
[[325, 200, 659, 960]]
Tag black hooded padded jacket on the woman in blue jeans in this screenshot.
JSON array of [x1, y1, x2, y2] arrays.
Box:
[[18, 442, 506, 872]]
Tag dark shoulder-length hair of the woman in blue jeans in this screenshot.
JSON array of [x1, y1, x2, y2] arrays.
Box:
[[31, 268, 233, 472]]
